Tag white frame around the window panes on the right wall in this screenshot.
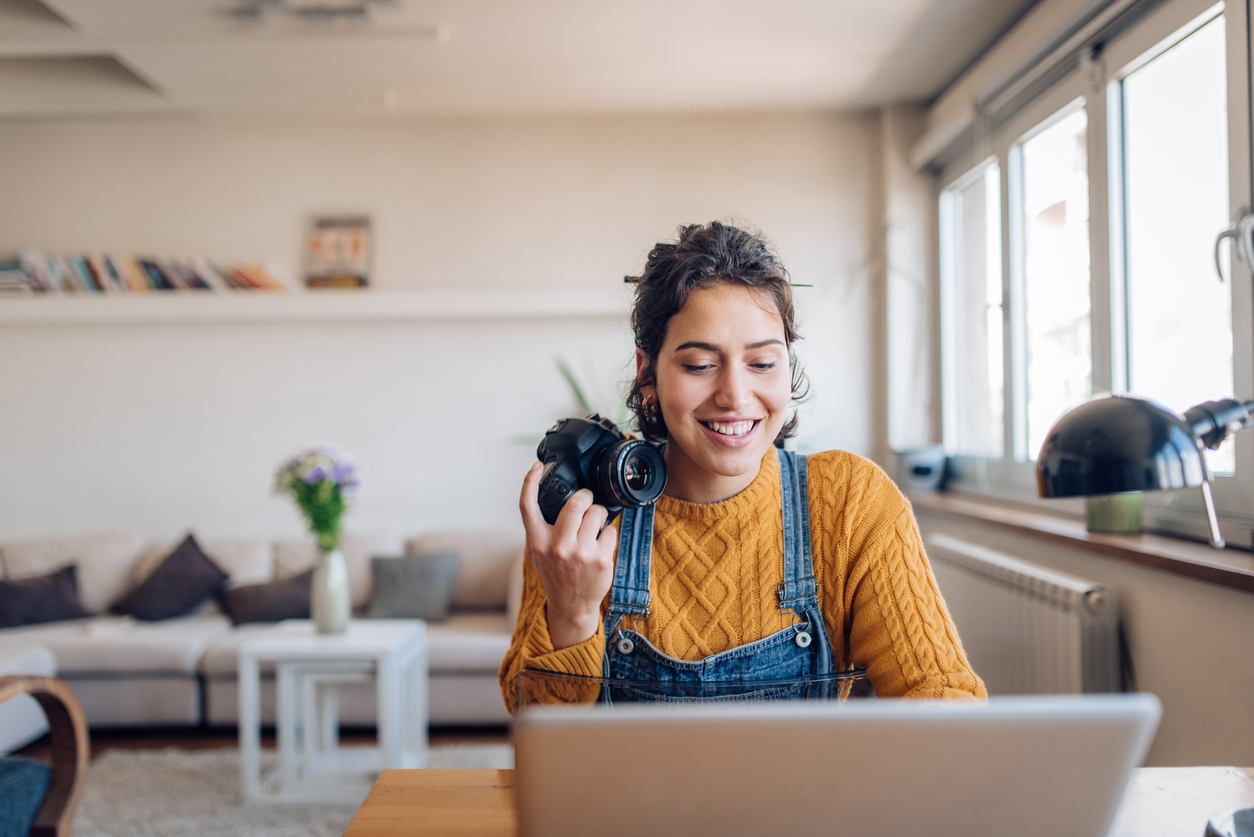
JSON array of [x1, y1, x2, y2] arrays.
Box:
[[937, 0, 1254, 546]]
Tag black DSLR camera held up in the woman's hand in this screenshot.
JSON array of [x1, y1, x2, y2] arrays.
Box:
[[535, 413, 666, 526]]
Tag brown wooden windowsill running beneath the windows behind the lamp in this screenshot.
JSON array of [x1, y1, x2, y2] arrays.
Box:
[[910, 493, 1254, 592]]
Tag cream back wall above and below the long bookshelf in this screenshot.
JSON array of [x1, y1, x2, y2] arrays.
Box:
[[0, 113, 877, 538]]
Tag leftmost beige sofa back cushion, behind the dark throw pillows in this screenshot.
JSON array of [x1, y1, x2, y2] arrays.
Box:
[[0, 532, 142, 614]]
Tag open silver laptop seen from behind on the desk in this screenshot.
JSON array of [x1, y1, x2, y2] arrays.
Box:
[[514, 694, 1161, 837]]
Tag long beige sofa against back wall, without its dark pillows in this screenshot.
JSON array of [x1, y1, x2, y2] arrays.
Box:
[[0, 531, 523, 749]]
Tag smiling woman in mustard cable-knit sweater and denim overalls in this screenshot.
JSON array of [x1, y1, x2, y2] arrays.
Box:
[[500, 222, 987, 710]]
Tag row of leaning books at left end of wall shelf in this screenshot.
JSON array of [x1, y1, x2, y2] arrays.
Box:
[[0, 247, 302, 296]]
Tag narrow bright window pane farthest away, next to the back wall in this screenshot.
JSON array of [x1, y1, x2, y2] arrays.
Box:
[[942, 164, 1004, 457]]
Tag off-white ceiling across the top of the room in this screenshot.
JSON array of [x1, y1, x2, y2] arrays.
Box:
[[0, 0, 1032, 118]]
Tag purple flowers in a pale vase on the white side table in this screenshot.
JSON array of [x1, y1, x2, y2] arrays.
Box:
[[275, 444, 361, 634]]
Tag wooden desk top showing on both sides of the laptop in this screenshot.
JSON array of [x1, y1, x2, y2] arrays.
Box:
[[344, 767, 1254, 837]]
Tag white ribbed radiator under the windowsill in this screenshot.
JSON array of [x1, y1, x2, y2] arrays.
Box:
[[927, 533, 1121, 695]]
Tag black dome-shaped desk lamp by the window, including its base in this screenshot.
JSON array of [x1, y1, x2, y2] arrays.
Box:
[[1036, 395, 1254, 837]]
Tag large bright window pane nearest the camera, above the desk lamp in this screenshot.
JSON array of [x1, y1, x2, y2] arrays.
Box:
[[1124, 16, 1235, 473]]
